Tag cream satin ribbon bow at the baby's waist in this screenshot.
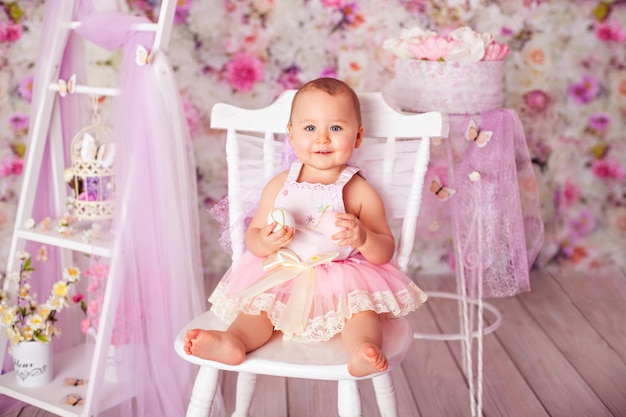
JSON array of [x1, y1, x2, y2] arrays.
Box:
[[239, 248, 339, 334]]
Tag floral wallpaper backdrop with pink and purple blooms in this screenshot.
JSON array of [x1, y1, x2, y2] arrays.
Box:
[[0, 0, 626, 286]]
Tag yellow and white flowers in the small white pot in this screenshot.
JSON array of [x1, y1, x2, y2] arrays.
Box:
[[0, 253, 81, 346]]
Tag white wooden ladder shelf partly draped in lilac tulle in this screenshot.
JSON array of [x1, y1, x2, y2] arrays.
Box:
[[0, 0, 176, 417]]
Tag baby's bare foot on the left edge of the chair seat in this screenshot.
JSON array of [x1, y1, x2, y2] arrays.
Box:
[[183, 329, 246, 365]]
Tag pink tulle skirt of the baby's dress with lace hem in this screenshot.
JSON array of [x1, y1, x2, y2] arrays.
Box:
[[209, 252, 427, 343]]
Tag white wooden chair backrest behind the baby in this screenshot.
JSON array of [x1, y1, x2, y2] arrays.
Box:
[[211, 90, 448, 271]]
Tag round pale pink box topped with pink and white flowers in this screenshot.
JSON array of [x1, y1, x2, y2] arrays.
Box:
[[383, 26, 509, 114]]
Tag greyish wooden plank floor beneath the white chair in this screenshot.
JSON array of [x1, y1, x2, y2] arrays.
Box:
[[0, 268, 626, 417]]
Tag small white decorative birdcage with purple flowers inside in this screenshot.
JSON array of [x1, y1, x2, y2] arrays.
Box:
[[67, 117, 115, 220]]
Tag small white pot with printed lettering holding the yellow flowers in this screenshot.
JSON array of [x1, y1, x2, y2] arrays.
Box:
[[11, 342, 53, 387]]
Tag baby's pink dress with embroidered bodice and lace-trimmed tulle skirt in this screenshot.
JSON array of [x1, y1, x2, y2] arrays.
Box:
[[209, 161, 427, 342]]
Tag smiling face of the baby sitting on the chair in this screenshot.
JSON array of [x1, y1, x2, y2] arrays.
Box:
[[289, 89, 363, 176]]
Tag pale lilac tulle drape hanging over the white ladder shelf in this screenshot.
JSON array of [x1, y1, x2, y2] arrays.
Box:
[[0, 1, 207, 417]]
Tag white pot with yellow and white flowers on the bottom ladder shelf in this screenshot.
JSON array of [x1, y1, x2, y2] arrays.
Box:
[[0, 252, 80, 387]]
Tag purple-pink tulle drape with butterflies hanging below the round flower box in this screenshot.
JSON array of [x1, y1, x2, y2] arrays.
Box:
[[418, 109, 544, 298]]
